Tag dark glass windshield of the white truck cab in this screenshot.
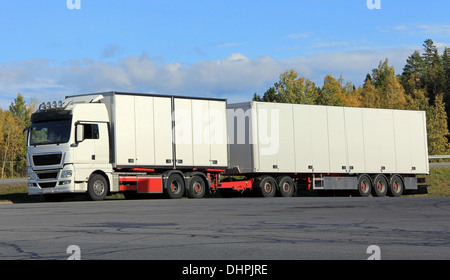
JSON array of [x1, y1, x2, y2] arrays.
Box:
[[30, 119, 72, 145]]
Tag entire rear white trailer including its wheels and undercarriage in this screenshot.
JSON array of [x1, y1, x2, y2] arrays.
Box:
[[228, 102, 429, 196]]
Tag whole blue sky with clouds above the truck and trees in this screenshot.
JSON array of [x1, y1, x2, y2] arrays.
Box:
[[0, 0, 450, 109]]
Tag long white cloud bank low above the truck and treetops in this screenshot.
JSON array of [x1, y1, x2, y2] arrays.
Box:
[[0, 48, 414, 109]]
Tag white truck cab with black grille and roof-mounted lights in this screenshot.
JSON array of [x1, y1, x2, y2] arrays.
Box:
[[27, 95, 113, 201]]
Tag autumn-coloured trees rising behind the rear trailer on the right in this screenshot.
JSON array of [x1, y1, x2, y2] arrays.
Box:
[[253, 39, 450, 158]]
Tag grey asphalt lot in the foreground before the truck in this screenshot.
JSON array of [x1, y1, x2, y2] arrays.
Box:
[[0, 197, 450, 260]]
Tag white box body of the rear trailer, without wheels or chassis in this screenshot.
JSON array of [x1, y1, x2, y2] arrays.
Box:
[[227, 102, 429, 174]]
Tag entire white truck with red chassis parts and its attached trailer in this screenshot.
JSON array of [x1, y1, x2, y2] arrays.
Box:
[[27, 92, 429, 201]]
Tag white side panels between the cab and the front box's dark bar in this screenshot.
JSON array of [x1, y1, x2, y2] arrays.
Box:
[[115, 94, 173, 167]]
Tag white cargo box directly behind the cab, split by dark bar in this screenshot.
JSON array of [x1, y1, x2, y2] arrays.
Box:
[[67, 92, 228, 168]]
